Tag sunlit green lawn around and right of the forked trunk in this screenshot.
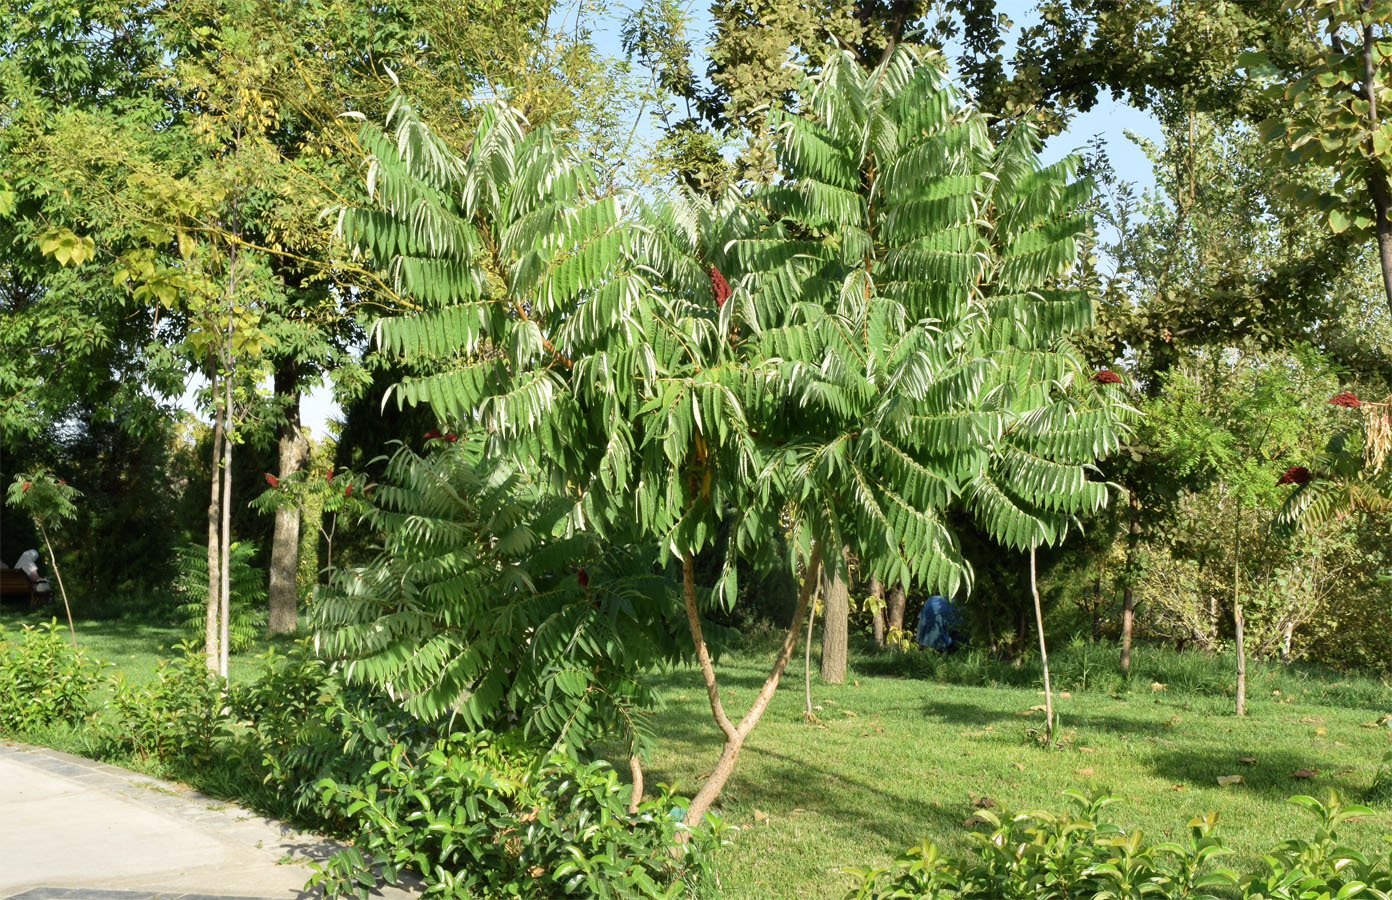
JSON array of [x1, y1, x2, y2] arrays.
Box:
[[647, 654, 1392, 900]]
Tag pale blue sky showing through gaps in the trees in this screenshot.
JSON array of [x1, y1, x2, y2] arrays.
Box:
[[302, 0, 1161, 437]]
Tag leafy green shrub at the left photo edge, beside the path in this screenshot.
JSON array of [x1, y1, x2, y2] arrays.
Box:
[[0, 619, 102, 734]]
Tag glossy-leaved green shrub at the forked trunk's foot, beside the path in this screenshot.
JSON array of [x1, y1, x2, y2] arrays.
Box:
[[310, 733, 721, 900]]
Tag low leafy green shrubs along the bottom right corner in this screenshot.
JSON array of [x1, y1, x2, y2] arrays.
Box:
[[844, 790, 1392, 900]]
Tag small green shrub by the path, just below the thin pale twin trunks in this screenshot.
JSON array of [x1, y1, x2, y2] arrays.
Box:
[[111, 643, 231, 769]]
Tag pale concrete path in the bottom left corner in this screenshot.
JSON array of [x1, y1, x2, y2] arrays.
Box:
[[0, 741, 413, 900]]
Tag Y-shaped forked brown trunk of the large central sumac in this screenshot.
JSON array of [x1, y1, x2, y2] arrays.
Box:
[[682, 544, 821, 840]]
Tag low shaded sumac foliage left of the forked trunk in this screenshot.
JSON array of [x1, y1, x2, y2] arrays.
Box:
[[317, 440, 678, 753]]
